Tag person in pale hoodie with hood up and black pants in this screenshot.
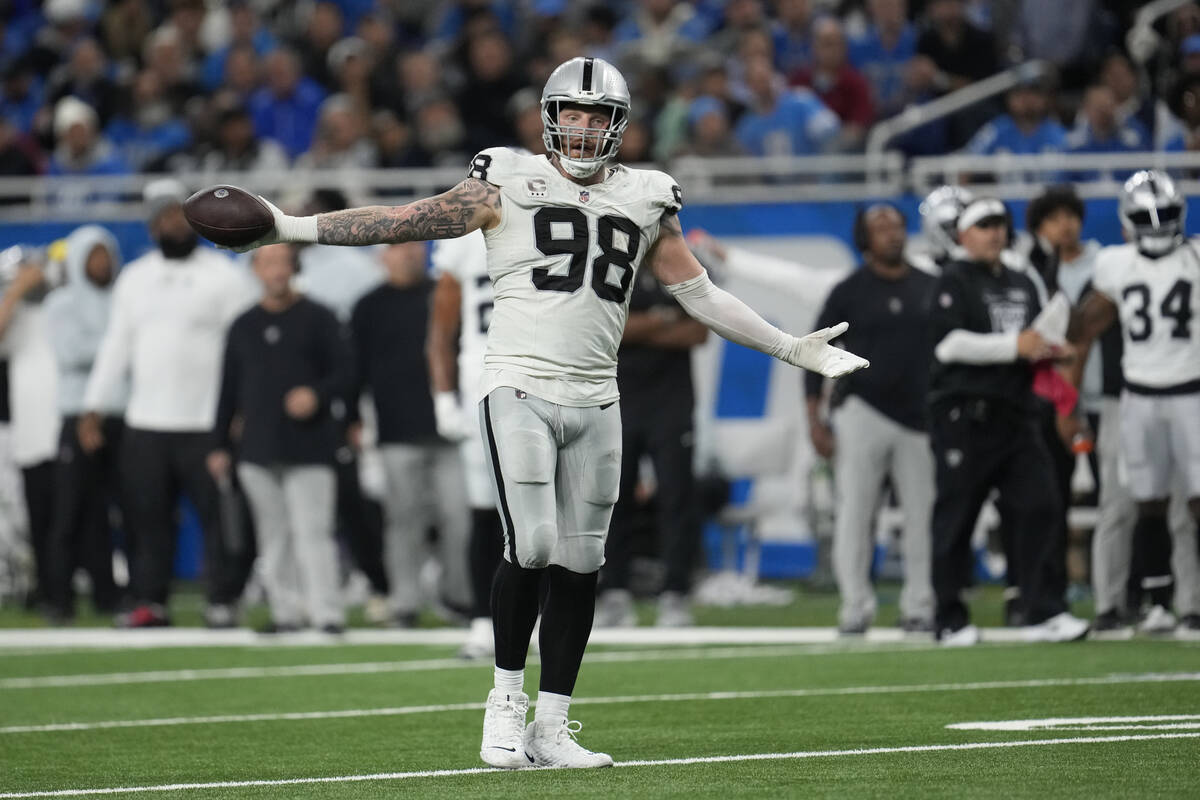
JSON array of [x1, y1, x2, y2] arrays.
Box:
[[46, 225, 128, 621]]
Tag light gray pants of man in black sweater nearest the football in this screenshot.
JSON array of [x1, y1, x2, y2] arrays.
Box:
[[238, 462, 346, 627]]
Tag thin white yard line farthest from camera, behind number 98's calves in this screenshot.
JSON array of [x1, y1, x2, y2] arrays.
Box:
[[0, 643, 935, 690]]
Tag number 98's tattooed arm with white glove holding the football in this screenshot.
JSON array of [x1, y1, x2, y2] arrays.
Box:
[[243, 178, 500, 251]]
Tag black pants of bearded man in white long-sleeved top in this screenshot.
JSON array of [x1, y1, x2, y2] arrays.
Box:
[[120, 428, 245, 604]]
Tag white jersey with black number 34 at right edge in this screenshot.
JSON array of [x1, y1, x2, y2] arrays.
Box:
[[1092, 241, 1200, 389]]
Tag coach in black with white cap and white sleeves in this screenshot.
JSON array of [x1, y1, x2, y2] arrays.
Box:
[[929, 199, 1087, 645]]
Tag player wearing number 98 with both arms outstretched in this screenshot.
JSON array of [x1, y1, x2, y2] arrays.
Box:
[[225, 58, 868, 768]]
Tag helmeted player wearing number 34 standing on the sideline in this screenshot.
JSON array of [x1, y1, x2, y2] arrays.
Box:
[[1070, 170, 1200, 627]]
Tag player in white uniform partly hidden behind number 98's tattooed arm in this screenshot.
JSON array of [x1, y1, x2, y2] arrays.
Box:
[[426, 230, 504, 658]]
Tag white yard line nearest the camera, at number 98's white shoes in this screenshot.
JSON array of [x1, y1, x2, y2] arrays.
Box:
[[0, 733, 1200, 800]]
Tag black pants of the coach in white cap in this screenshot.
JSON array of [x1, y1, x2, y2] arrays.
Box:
[[930, 398, 1066, 631]]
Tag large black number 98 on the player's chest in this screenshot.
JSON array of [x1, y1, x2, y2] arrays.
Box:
[[533, 206, 638, 302]]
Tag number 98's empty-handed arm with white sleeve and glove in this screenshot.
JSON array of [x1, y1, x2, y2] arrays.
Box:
[[649, 215, 869, 378]]
